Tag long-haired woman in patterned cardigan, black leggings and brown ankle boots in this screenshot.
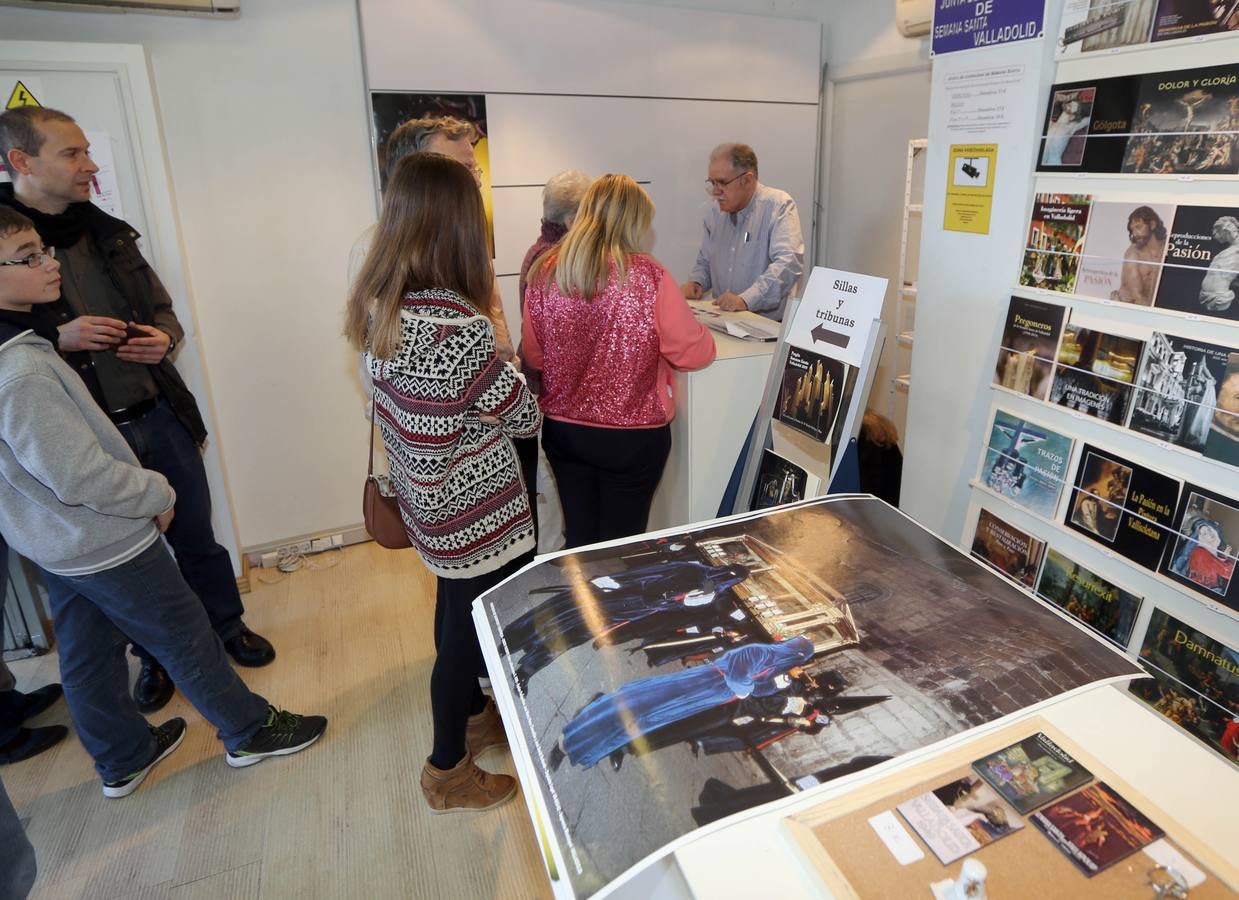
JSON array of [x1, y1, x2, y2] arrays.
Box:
[[344, 154, 540, 812]]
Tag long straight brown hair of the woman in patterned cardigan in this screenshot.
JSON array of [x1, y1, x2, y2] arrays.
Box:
[[344, 152, 494, 360]]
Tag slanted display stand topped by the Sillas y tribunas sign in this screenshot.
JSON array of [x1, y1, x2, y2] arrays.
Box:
[[733, 267, 886, 512]]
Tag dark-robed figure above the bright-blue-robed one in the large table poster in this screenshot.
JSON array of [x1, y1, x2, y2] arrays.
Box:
[[503, 559, 748, 692]]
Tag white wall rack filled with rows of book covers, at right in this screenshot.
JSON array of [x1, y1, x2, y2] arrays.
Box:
[[946, 15, 1239, 788]]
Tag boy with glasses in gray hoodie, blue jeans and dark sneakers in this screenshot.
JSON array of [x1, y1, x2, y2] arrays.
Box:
[[0, 207, 327, 797]]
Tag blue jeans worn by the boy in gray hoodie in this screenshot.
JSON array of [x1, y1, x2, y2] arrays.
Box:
[[43, 540, 266, 781]]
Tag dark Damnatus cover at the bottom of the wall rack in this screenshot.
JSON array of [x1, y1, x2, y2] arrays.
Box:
[[1127, 609, 1239, 766]]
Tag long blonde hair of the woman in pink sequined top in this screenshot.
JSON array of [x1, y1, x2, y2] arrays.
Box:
[[540, 175, 654, 300]]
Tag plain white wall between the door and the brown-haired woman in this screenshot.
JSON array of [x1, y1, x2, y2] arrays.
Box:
[[0, 0, 374, 547]]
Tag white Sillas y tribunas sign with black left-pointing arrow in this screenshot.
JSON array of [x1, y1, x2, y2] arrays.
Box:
[[787, 268, 886, 366]]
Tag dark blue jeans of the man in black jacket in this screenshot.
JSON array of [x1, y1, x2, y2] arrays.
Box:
[[116, 398, 245, 664]]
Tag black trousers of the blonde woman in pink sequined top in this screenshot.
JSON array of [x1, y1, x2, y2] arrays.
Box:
[[543, 419, 672, 548]]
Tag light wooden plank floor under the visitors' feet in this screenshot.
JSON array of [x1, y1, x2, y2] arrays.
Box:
[[0, 544, 551, 900]]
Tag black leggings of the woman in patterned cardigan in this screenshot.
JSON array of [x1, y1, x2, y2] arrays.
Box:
[[430, 550, 534, 769]]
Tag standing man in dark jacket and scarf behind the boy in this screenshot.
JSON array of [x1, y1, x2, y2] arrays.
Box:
[[0, 107, 275, 713]]
